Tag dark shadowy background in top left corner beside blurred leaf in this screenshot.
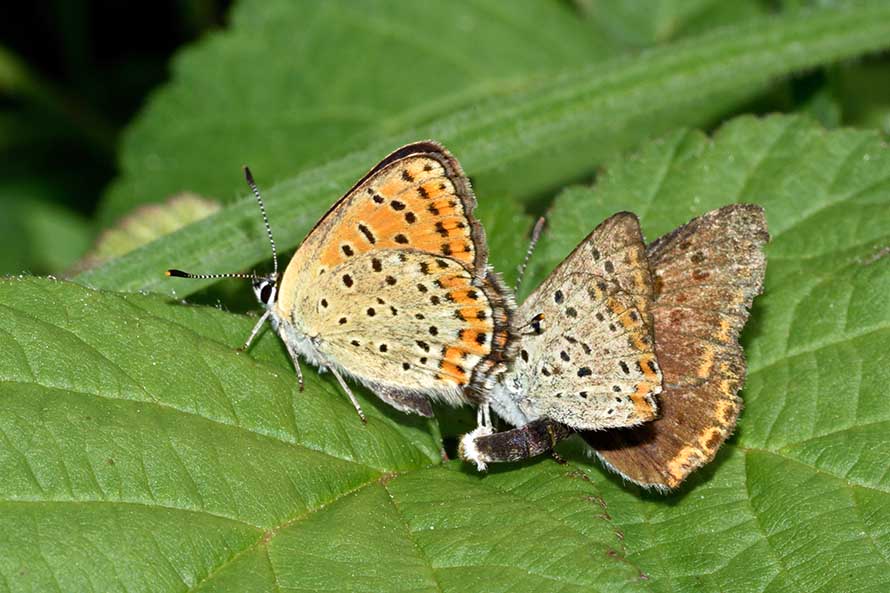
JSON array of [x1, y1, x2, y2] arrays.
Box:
[[0, 0, 230, 274]]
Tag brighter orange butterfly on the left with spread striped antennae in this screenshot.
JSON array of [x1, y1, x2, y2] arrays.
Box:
[[167, 141, 515, 421]]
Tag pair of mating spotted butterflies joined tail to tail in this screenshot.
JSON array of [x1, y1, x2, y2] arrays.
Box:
[[167, 142, 767, 487]]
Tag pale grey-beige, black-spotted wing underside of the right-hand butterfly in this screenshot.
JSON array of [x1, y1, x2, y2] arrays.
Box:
[[513, 213, 661, 430]]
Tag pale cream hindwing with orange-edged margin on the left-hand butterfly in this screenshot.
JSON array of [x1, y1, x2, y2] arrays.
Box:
[[299, 249, 508, 415]]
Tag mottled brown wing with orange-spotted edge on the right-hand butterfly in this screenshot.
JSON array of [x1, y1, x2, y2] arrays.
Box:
[[584, 204, 769, 489]]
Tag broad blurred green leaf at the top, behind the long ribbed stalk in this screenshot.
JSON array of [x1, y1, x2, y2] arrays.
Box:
[[104, 0, 619, 220]]
